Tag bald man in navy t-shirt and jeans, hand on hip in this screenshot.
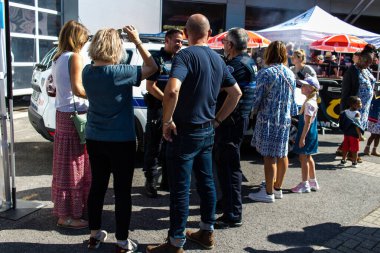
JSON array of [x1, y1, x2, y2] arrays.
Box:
[[147, 14, 241, 253]]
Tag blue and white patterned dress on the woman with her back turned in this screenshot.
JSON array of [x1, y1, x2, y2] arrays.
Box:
[[251, 64, 297, 157]]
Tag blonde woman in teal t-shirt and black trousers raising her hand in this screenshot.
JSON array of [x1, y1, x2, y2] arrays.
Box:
[[83, 26, 158, 252]]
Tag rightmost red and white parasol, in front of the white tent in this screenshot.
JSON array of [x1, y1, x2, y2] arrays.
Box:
[[310, 34, 368, 53]]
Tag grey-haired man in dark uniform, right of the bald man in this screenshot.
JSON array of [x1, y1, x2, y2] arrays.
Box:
[[214, 28, 257, 228]]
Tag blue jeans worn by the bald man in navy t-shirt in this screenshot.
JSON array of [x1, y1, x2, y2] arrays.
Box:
[[166, 127, 216, 247]]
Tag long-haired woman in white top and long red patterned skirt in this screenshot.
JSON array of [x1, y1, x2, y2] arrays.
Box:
[[52, 20, 91, 229]]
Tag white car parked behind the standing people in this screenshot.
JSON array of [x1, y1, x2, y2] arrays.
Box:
[[28, 39, 164, 151]]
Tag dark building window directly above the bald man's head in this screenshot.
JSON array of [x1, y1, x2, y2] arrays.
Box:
[[162, 0, 226, 35]]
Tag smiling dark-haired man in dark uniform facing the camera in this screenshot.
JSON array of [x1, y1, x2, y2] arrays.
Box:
[[143, 29, 182, 198]]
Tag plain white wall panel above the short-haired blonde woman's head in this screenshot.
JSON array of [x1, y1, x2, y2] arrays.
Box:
[[78, 0, 162, 34]]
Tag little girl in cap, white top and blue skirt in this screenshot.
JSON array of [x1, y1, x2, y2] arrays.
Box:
[[292, 76, 320, 193]]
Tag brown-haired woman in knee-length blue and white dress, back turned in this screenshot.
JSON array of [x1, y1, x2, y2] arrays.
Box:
[[248, 41, 297, 203]]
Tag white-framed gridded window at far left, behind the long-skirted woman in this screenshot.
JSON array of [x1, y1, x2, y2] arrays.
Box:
[[9, 0, 62, 95]]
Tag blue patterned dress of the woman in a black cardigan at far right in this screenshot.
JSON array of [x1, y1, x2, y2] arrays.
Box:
[[358, 69, 376, 129]]
